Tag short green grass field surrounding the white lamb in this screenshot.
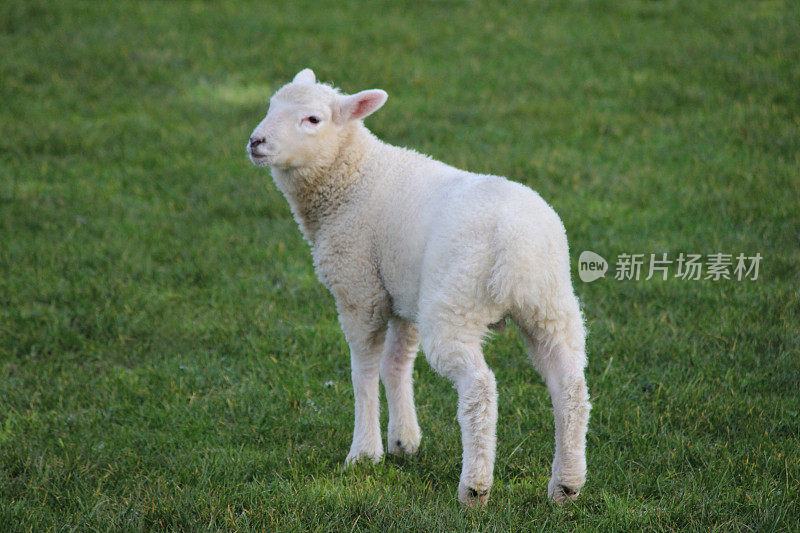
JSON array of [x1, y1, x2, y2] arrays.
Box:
[[0, 0, 800, 531]]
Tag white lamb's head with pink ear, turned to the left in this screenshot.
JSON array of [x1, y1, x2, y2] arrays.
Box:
[[247, 69, 387, 169]]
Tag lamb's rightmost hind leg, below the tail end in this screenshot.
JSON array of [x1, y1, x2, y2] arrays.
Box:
[[517, 297, 591, 504]]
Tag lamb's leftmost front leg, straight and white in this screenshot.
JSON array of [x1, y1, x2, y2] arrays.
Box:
[[341, 317, 385, 466]]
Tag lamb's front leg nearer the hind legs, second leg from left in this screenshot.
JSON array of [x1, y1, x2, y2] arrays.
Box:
[[380, 318, 421, 455]]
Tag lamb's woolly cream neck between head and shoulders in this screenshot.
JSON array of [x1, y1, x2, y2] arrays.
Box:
[[273, 124, 380, 246]]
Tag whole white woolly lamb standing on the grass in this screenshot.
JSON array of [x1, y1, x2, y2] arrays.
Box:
[[247, 69, 591, 506]]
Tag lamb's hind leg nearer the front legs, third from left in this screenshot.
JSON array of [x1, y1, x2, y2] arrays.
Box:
[[421, 325, 497, 507]]
